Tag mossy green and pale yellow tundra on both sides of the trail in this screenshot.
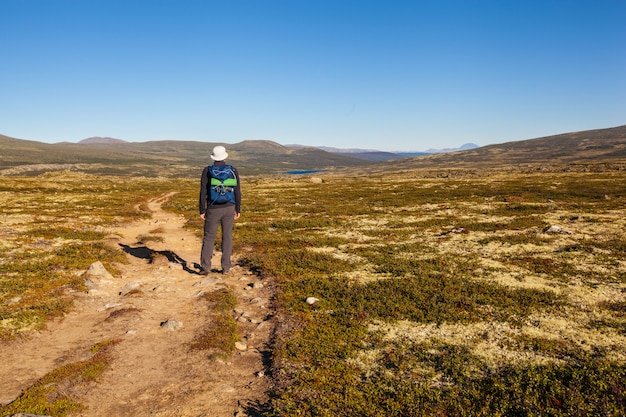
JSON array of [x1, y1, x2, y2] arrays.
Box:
[[0, 170, 626, 416]]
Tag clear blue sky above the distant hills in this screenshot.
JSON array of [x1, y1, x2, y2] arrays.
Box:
[[0, 0, 626, 151]]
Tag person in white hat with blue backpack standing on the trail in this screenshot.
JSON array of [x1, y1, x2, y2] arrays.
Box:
[[199, 146, 241, 275]]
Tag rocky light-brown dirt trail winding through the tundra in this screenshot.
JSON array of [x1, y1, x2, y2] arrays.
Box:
[[0, 195, 272, 417]]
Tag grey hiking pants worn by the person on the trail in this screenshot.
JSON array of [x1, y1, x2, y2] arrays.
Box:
[[200, 205, 235, 271]]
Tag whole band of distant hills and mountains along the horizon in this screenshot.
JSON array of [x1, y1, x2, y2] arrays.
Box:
[[0, 125, 626, 177]]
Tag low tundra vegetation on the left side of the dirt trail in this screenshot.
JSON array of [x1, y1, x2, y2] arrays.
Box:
[[0, 172, 172, 416]]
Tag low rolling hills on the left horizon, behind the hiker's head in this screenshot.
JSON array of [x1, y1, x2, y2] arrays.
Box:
[[0, 135, 369, 177]]
